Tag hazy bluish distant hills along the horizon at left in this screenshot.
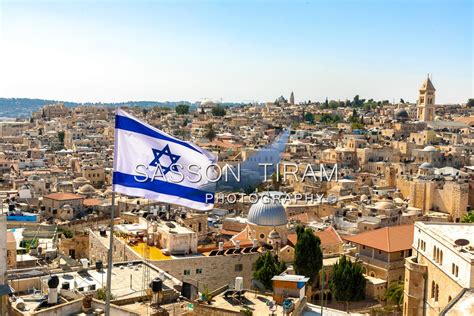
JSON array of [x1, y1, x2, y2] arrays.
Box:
[[0, 98, 243, 119]]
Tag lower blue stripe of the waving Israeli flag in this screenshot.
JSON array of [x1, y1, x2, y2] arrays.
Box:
[[113, 171, 214, 204]]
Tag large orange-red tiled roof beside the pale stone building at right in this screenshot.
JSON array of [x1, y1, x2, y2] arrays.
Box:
[[344, 225, 414, 252]]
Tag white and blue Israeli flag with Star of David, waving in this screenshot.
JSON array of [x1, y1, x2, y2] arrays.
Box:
[[113, 109, 217, 210]]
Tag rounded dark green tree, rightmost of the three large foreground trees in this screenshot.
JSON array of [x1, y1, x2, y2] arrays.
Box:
[[329, 256, 366, 308]]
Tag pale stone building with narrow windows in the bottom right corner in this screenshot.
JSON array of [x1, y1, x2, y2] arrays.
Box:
[[403, 222, 474, 316]]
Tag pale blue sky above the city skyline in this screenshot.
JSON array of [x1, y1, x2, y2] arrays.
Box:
[[0, 0, 474, 102]]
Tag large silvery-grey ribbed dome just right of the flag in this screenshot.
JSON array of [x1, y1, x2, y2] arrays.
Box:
[[247, 196, 288, 226]]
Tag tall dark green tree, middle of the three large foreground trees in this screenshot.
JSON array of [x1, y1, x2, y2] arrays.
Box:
[[294, 226, 323, 282]]
